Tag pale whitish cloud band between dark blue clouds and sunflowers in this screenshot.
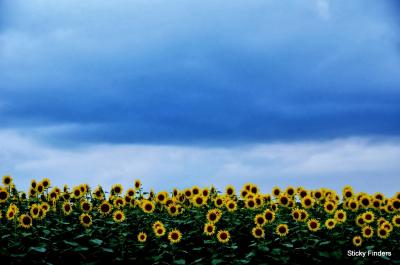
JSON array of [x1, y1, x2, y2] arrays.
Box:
[[0, 130, 400, 195]]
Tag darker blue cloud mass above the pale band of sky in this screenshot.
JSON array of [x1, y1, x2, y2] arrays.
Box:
[[0, 0, 400, 144]]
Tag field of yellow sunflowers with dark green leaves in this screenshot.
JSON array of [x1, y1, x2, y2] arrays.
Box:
[[0, 176, 400, 264]]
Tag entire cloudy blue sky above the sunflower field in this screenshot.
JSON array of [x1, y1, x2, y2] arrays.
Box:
[[0, 0, 400, 194]]
